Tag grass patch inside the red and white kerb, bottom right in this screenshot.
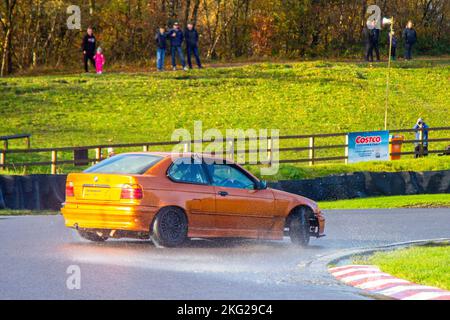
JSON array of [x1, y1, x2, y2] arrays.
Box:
[[355, 245, 450, 290]]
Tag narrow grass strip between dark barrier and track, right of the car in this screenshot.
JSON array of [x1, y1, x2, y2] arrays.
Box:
[[319, 194, 450, 210]]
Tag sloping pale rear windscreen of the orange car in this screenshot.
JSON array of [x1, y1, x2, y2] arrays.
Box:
[[84, 154, 162, 174]]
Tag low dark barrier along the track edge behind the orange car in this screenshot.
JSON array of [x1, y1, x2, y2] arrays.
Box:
[[0, 170, 450, 210]]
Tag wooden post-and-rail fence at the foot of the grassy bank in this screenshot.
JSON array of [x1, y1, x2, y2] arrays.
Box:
[[0, 127, 450, 174]]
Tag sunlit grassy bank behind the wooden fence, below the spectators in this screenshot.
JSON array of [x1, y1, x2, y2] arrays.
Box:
[[0, 59, 450, 177]]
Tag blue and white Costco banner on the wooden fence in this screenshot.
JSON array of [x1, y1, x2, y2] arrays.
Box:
[[348, 131, 389, 163]]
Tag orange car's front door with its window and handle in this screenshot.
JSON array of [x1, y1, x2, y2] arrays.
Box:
[[205, 163, 275, 236]]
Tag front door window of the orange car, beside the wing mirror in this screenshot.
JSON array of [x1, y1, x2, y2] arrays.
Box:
[[207, 164, 255, 190]]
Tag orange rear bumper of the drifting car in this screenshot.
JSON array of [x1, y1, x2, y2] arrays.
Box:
[[61, 203, 158, 232]]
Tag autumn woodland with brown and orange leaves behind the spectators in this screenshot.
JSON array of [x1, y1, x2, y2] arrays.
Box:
[[0, 0, 450, 75]]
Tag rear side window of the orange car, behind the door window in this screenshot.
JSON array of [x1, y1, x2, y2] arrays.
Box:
[[167, 159, 208, 185]]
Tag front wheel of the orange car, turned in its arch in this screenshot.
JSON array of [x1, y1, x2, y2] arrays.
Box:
[[288, 207, 313, 247]]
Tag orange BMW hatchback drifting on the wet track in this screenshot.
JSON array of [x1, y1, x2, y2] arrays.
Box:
[[62, 152, 325, 247]]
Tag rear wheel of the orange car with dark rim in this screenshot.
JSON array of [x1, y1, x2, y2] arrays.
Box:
[[151, 207, 188, 247]]
